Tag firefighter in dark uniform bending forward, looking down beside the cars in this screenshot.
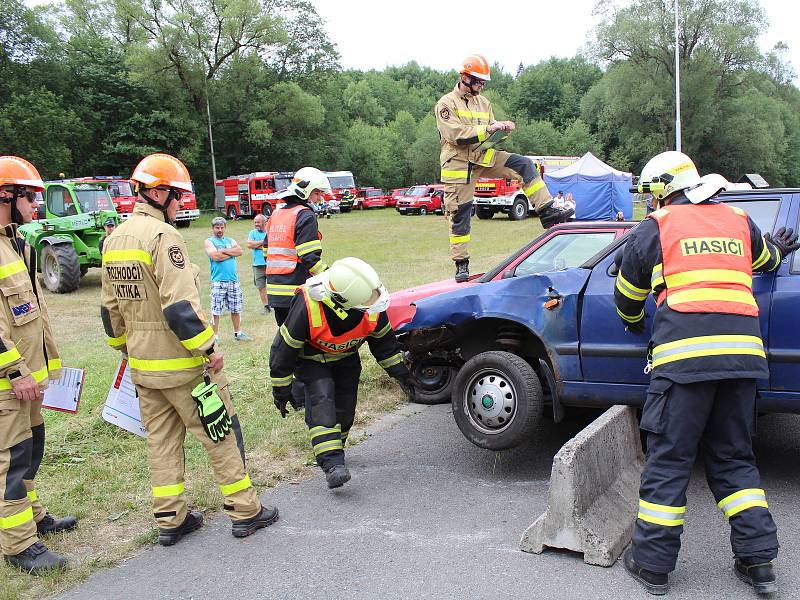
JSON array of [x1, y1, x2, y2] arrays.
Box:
[[269, 257, 410, 488]]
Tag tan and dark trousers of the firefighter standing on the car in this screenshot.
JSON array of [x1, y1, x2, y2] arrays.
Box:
[[444, 150, 550, 260]]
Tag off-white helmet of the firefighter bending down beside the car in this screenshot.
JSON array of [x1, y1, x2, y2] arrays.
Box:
[[306, 256, 389, 314]]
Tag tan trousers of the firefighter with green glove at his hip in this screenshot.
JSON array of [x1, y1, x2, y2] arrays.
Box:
[[136, 375, 261, 529]]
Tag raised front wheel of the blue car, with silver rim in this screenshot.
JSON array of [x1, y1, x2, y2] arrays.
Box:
[[452, 351, 543, 450]]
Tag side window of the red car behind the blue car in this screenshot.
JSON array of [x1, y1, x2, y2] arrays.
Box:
[[514, 231, 615, 277]]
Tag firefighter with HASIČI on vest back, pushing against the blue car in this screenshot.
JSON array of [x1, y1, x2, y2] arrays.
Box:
[[614, 152, 799, 594]]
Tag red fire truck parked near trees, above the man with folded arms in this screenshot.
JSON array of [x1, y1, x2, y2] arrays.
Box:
[[214, 171, 294, 220]]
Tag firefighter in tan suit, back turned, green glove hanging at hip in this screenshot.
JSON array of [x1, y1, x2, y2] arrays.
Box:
[[101, 154, 278, 546]]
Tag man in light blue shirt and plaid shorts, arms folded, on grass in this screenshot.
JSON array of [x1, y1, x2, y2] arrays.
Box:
[[205, 217, 250, 341]]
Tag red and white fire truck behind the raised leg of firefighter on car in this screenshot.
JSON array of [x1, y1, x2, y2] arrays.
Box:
[[474, 156, 579, 221]]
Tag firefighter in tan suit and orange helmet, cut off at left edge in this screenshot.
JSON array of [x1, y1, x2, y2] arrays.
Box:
[[0, 156, 77, 575]]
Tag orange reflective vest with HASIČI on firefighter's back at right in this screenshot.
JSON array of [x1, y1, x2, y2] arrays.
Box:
[[648, 204, 758, 317]]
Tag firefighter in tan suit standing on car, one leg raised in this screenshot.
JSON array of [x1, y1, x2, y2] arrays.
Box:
[[435, 54, 574, 282]]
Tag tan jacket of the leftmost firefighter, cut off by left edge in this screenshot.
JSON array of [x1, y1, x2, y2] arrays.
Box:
[[0, 225, 61, 410]]
